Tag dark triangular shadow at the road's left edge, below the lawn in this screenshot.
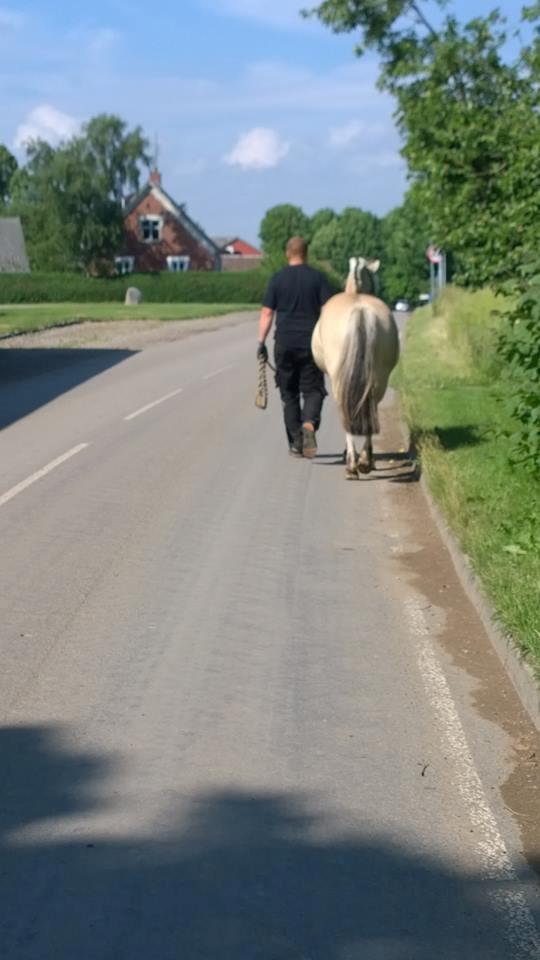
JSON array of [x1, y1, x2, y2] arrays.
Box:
[[0, 347, 134, 430]]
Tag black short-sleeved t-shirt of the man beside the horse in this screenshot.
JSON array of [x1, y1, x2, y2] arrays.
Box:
[[263, 263, 332, 349]]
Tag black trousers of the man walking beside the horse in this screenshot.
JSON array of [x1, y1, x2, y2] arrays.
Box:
[[275, 341, 326, 444]]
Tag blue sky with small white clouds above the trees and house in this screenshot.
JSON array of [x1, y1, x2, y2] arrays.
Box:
[[0, 0, 528, 240]]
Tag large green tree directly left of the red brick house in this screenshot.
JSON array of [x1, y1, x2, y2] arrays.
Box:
[[10, 115, 148, 273]]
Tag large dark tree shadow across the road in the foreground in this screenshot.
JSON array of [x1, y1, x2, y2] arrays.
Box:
[[0, 727, 524, 960]]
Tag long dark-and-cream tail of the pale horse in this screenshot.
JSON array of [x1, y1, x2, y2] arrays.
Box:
[[334, 307, 379, 436]]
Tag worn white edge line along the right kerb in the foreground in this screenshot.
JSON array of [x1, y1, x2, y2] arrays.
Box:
[[405, 599, 540, 960]]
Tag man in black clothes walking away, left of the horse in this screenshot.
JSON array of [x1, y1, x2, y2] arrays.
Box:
[[257, 237, 332, 458]]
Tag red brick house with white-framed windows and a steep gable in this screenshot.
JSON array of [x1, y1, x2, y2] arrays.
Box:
[[115, 170, 221, 274]]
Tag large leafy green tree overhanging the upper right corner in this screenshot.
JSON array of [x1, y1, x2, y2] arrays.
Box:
[[313, 0, 540, 284]]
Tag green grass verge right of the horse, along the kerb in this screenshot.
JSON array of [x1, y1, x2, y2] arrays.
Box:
[[397, 290, 540, 677]]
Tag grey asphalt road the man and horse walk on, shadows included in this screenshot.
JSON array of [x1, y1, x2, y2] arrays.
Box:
[[0, 321, 540, 960]]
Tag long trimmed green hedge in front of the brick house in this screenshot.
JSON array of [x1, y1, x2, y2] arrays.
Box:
[[0, 270, 268, 304]]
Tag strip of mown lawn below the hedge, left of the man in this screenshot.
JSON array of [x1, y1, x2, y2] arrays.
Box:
[[0, 303, 257, 336]]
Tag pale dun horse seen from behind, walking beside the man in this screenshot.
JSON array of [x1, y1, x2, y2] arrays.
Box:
[[312, 257, 399, 477]]
